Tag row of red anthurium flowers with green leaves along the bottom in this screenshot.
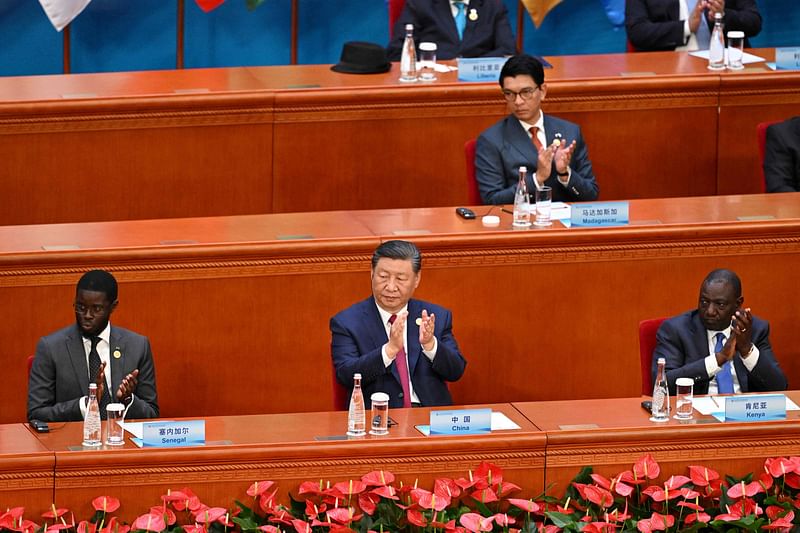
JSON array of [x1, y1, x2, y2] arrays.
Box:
[[0, 454, 800, 533]]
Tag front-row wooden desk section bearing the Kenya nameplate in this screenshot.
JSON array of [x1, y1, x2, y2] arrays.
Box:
[[514, 391, 800, 496]]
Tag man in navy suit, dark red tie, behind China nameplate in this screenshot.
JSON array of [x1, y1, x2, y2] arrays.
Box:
[[330, 241, 467, 407]]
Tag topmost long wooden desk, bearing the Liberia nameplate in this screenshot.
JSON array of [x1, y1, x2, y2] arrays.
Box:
[[0, 50, 800, 225]]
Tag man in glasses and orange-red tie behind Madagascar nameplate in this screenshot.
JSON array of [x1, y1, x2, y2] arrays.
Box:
[[475, 54, 598, 204]]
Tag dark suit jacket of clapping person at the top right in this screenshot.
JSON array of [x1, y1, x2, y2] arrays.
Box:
[[625, 0, 761, 51]]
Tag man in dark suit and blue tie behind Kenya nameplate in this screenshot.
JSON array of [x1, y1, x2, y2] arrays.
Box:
[[653, 270, 787, 394]]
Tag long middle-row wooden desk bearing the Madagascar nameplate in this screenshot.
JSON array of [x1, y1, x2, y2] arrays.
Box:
[[0, 194, 800, 422]]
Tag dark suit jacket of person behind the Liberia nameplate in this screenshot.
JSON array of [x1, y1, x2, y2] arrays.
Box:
[[386, 0, 517, 61]]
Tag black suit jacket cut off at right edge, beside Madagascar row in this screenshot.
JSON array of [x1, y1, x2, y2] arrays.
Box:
[[764, 116, 800, 192]]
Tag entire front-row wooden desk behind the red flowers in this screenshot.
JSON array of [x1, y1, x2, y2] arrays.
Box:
[[9, 391, 800, 521]]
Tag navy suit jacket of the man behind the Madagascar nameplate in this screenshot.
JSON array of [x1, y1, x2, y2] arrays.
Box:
[[475, 115, 598, 204]]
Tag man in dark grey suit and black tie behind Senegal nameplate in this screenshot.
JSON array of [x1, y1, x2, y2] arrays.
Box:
[[28, 270, 158, 422]]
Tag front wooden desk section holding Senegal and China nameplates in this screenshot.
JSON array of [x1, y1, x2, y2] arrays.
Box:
[[31, 404, 546, 520]]
